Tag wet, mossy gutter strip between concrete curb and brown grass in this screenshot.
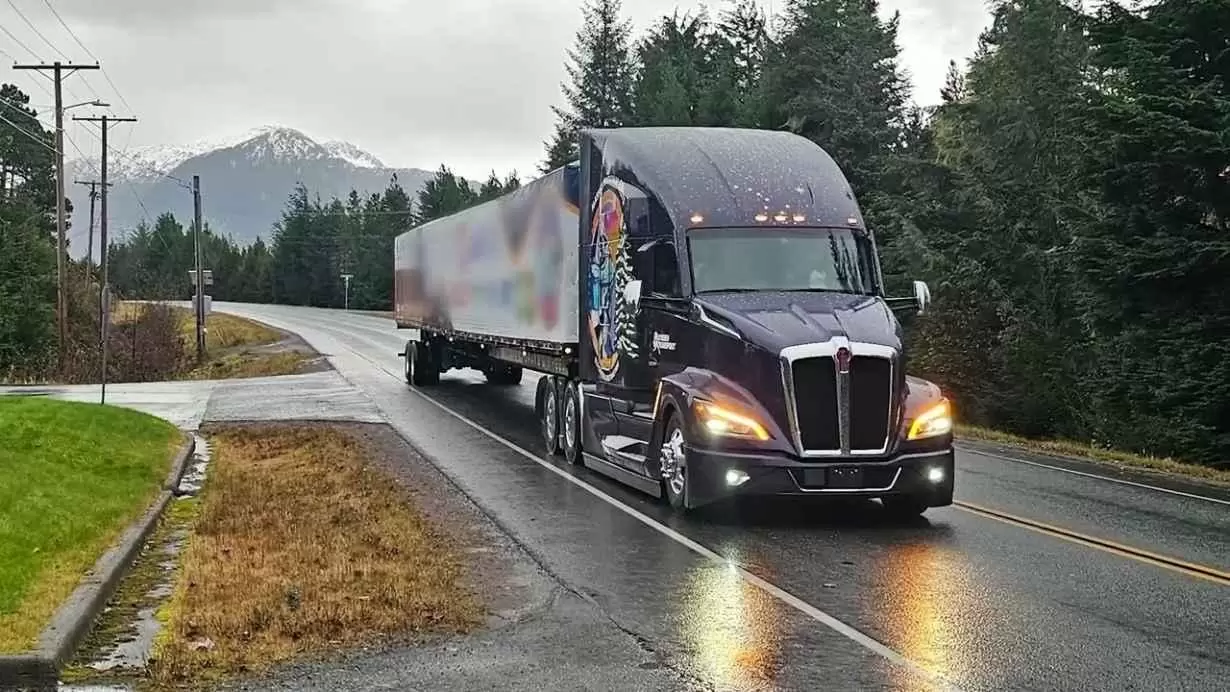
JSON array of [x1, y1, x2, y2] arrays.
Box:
[[59, 435, 210, 692]]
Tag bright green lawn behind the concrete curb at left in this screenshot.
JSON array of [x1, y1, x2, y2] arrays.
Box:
[[0, 397, 182, 653]]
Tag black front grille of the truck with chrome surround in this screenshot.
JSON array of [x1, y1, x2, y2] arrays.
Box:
[[790, 355, 893, 452]]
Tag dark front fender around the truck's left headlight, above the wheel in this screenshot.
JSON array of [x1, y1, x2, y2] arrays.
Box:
[[648, 368, 793, 454]]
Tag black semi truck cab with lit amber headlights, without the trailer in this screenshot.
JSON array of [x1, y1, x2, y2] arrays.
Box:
[[538, 128, 953, 515]]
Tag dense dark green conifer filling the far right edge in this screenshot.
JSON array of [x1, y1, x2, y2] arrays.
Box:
[[1073, 0, 1230, 463]]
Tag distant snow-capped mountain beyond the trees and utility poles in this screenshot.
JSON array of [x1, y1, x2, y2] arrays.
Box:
[[68, 125, 432, 257]]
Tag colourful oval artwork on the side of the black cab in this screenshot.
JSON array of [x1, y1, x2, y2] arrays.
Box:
[[585, 181, 637, 382]]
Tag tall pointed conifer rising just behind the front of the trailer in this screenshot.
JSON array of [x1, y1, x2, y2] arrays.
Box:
[[542, 0, 633, 172]]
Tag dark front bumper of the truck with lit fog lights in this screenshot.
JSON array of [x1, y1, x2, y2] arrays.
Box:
[[686, 446, 954, 508]]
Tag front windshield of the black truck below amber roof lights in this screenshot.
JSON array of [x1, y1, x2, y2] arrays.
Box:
[[688, 229, 876, 295]]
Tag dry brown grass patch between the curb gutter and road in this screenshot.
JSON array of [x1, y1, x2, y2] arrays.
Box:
[[150, 427, 482, 686]]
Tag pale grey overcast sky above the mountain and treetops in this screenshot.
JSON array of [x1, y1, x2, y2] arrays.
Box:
[[0, 0, 988, 177]]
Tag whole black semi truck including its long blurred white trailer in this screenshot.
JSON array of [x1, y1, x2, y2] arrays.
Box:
[[395, 128, 953, 515]]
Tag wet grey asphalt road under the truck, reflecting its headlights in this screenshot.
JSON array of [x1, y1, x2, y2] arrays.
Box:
[[215, 304, 1230, 690]]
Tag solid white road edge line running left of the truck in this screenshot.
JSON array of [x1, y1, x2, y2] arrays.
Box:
[[403, 378, 959, 690]]
